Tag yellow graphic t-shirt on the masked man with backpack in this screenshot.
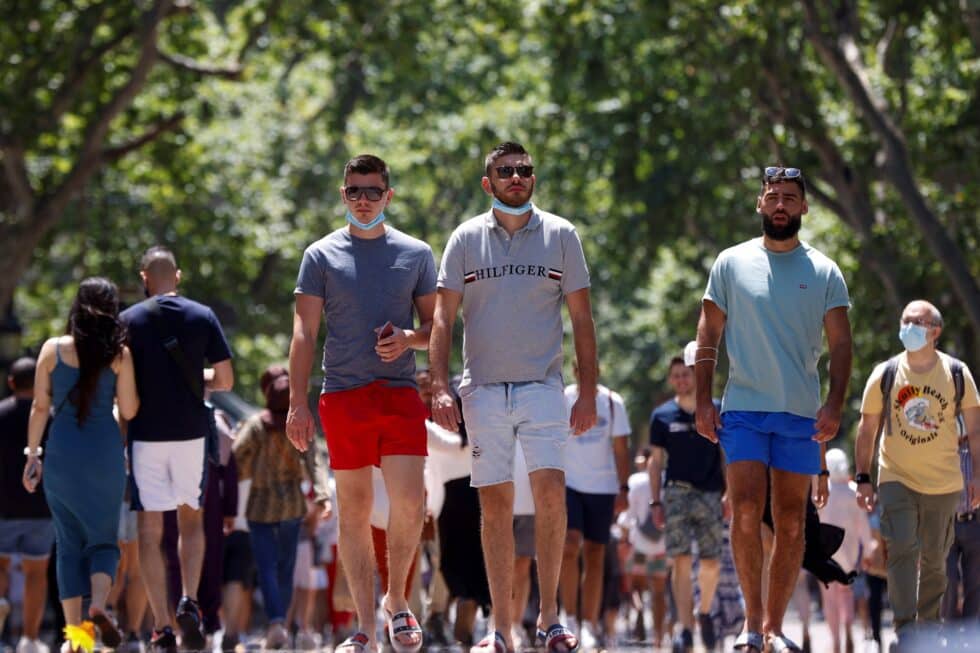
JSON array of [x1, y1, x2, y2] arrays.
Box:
[[861, 352, 980, 494]]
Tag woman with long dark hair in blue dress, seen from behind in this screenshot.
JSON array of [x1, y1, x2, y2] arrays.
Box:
[[24, 277, 139, 652]]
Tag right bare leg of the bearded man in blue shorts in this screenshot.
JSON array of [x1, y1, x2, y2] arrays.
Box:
[[763, 469, 810, 635]]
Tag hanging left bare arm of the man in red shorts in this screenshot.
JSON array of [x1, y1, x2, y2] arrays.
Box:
[[286, 295, 323, 451]]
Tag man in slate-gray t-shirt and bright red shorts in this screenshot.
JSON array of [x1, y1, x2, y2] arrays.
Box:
[[286, 154, 436, 653]]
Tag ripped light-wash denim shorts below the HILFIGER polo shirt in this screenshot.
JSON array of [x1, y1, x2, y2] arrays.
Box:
[[460, 377, 570, 487]]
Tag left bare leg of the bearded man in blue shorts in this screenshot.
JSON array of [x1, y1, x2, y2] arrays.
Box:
[[728, 460, 766, 632]]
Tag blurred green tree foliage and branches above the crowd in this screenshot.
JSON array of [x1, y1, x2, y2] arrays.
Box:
[[0, 0, 980, 444]]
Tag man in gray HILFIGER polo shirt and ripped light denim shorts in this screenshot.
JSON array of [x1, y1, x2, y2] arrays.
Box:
[[429, 142, 597, 653]]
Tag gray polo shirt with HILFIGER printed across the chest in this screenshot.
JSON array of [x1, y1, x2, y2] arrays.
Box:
[[439, 207, 589, 387]]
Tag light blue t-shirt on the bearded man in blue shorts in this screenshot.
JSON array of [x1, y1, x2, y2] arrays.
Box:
[[704, 237, 850, 417]]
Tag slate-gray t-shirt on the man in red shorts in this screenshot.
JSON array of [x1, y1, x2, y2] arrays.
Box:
[[294, 227, 436, 392]]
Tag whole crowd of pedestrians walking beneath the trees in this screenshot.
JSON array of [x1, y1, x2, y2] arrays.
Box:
[[0, 150, 980, 653]]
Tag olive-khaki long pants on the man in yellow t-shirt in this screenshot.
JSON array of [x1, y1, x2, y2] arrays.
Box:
[[878, 482, 960, 631]]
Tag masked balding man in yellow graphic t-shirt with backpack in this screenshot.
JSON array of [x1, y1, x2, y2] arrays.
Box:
[[855, 300, 980, 646]]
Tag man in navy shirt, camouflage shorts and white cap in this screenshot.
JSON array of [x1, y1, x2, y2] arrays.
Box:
[[647, 342, 725, 651]]
